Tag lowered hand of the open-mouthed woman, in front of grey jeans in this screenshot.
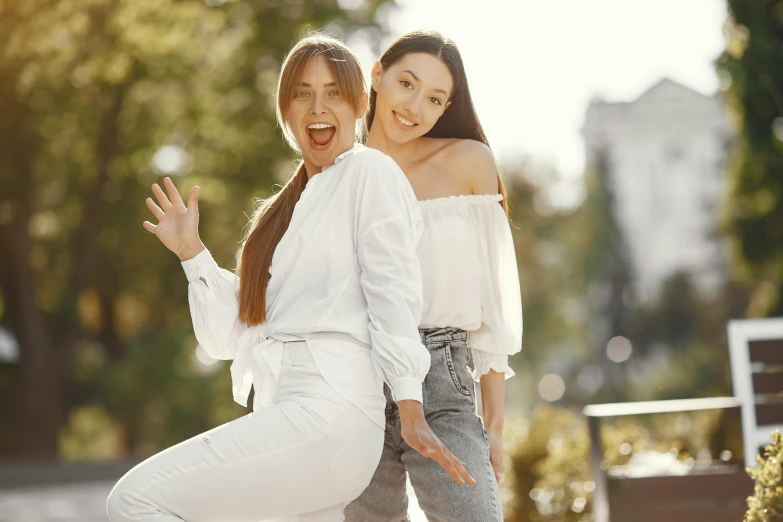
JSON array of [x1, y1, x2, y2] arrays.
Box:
[[397, 400, 476, 486]]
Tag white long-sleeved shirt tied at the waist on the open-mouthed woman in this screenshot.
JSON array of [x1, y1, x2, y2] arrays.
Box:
[[182, 145, 430, 426]]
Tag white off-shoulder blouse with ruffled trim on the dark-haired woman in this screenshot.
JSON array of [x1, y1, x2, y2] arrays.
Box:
[[418, 194, 522, 381]]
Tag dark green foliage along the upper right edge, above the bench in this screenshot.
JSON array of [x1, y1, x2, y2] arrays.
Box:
[[716, 0, 783, 316]]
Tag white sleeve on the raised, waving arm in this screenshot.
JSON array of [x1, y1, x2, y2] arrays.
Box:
[[182, 249, 246, 360]]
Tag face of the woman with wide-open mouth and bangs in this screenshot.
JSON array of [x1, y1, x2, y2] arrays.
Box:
[[283, 56, 367, 176]]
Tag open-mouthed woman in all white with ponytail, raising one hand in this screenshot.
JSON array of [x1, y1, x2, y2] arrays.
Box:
[[108, 31, 475, 522]]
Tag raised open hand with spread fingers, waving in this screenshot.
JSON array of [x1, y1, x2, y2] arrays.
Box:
[[144, 177, 205, 261]]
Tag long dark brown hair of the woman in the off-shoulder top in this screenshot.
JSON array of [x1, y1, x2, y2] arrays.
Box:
[[365, 31, 508, 215]]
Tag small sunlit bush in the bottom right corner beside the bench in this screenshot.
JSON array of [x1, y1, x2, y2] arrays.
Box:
[[745, 430, 783, 522]]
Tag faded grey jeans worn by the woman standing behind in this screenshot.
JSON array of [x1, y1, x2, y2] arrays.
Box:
[[345, 328, 503, 522]]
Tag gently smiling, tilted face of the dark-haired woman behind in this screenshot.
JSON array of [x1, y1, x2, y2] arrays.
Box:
[[373, 53, 454, 144]]
